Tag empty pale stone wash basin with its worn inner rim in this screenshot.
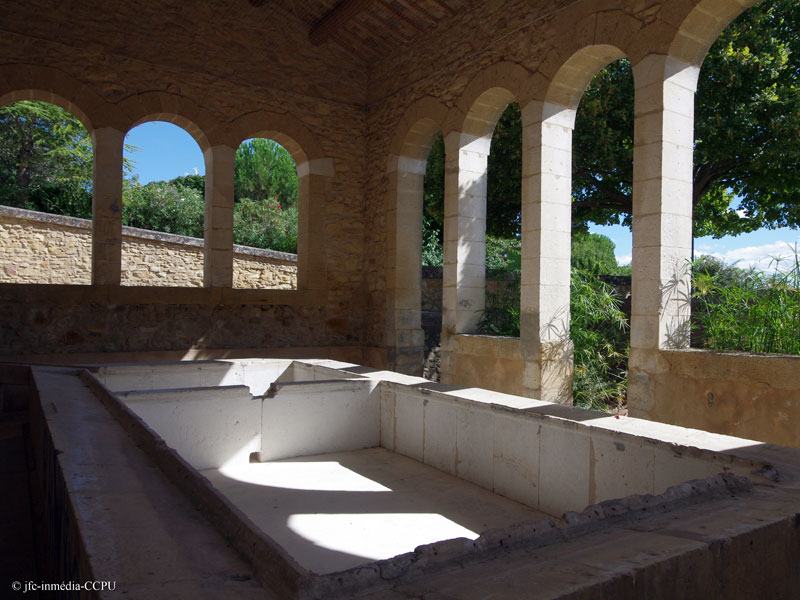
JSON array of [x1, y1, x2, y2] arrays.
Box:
[[72, 359, 768, 598]]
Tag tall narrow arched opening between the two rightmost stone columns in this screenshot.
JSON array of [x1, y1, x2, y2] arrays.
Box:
[[570, 58, 634, 410]]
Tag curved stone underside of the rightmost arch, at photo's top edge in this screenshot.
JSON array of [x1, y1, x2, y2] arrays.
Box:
[[668, 0, 760, 67]]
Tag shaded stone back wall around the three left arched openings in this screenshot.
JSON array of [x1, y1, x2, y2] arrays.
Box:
[[0, 0, 370, 356]]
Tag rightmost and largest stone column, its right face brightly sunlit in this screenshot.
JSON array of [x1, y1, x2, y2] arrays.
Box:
[[628, 55, 699, 416]]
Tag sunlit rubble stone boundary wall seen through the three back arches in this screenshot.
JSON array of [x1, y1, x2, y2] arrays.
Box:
[[0, 206, 297, 289]]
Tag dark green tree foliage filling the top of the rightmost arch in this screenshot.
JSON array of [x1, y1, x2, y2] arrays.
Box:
[[694, 0, 800, 236]]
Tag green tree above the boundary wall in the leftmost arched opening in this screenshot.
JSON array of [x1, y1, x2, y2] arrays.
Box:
[[0, 101, 92, 218]]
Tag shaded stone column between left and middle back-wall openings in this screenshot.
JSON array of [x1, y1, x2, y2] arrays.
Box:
[[92, 127, 125, 285]]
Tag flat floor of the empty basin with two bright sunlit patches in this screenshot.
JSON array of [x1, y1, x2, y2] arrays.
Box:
[[202, 448, 545, 574]]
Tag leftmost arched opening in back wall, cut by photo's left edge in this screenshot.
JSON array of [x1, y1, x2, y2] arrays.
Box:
[[0, 100, 94, 285]]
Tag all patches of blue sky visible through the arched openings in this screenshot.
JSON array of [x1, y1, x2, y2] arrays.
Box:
[[125, 121, 800, 269]]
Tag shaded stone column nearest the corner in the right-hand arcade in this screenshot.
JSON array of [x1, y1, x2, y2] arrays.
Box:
[[386, 156, 427, 376]]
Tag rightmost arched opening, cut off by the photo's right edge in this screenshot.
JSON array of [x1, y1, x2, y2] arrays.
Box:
[[691, 0, 800, 354]]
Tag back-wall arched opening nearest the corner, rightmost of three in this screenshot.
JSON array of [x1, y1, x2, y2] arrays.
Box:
[[233, 138, 299, 289]]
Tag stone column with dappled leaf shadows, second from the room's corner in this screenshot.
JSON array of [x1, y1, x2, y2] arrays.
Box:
[[440, 132, 491, 383]]
